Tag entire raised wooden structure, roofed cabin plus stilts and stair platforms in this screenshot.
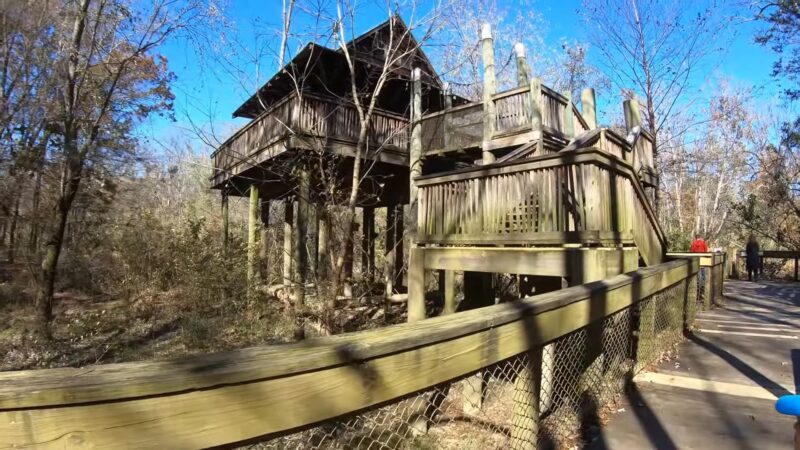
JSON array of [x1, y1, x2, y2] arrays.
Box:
[[208, 18, 666, 312]]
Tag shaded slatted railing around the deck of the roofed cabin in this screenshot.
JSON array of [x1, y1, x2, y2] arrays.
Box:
[[211, 93, 408, 185]]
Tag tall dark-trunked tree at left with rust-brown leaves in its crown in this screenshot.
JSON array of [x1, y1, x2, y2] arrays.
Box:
[[36, 0, 211, 337]]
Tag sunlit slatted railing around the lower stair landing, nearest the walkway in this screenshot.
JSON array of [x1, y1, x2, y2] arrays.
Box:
[[417, 148, 666, 264]]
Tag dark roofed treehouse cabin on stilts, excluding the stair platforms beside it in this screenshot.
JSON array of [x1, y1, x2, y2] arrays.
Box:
[[212, 16, 466, 295]]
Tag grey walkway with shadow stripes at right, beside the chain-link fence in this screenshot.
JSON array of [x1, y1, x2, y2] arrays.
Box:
[[589, 281, 800, 450]]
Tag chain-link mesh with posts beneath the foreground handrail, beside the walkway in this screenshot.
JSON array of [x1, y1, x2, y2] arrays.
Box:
[[253, 280, 698, 450]]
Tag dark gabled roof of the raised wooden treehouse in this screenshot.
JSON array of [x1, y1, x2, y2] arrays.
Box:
[[233, 15, 450, 118]]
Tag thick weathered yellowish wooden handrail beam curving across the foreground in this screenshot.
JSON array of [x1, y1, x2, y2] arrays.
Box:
[[0, 260, 697, 449]]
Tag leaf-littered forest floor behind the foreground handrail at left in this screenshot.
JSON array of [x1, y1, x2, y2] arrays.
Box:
[[0, 263, 404, 371]]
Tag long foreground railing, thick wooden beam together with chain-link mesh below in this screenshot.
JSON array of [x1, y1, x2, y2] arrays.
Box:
[[0, 260, 697, 449]]
